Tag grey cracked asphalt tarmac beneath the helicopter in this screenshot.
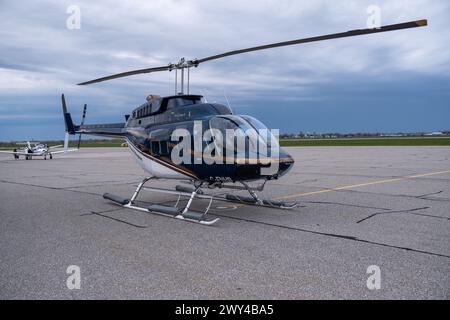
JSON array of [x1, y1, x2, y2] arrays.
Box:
[[0, 147, 450, 299]]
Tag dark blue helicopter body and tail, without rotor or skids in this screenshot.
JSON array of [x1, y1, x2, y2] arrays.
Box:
[[65, 95, 294, 182]]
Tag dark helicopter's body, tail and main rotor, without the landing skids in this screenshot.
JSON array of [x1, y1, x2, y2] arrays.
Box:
[[67, 19, 428, 185]]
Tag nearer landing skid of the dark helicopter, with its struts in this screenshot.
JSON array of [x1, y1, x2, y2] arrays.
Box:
[[103, 177, 219, 225]]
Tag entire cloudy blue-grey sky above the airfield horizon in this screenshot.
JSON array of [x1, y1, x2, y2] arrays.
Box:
[[0, 0, 450, 141]]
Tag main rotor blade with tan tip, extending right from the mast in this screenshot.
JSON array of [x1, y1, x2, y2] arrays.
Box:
[[194, 19, 428, 63]]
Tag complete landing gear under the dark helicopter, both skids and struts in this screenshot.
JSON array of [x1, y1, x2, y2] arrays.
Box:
[[103, 177, 298, 225]]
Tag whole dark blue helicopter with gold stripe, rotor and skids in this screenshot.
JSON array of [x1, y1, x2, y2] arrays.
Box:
[[61, 20, 428, 225]]
